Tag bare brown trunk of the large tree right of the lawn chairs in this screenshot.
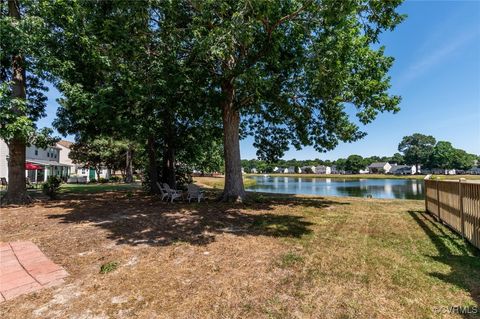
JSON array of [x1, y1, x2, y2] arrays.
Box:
[[221, 81, 245, 202]]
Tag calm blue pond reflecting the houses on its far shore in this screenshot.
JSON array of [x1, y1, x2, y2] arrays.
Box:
[[246, 176, 424, 199]]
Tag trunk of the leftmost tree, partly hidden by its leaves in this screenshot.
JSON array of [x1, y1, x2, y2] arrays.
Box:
[[2, 0, 31, 204]]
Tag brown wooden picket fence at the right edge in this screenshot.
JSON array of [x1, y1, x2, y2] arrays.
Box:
[[425, 180, 480, 248]]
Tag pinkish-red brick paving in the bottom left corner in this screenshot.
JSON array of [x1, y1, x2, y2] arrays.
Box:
[[0, 241, 68, 302]]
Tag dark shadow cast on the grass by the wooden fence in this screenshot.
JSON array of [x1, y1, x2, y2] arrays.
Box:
[[409, 211, 480, 318]]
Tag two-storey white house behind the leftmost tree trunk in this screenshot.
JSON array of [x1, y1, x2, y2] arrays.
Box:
[[0, 139, 73, 182]]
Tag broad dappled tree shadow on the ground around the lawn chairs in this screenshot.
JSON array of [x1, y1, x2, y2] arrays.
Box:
[[46, 193, 344, 246]]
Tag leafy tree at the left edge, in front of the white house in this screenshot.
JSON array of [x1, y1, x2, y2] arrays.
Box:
[[0, 0, 53, 204]]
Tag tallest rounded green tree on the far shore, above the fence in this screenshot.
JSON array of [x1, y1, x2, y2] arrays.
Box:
[[398, 133, 436, 172]]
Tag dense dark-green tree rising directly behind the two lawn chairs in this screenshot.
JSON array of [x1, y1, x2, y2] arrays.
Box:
[[47, 0, 218, 191]]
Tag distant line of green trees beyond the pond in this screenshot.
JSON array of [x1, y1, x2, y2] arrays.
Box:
[[242, 133, 480, 173]]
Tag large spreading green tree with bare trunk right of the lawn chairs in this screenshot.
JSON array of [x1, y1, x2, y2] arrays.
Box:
[[189, 0, 403, 201]]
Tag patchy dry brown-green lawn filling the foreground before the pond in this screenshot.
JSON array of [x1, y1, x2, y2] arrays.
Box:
[[0, 185, 480, 318]]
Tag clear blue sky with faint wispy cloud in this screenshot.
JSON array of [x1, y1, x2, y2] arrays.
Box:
[[38, 0, 480, 159]]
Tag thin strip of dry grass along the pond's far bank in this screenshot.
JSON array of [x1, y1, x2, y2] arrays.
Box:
[[246, 174, 480, 180]]
